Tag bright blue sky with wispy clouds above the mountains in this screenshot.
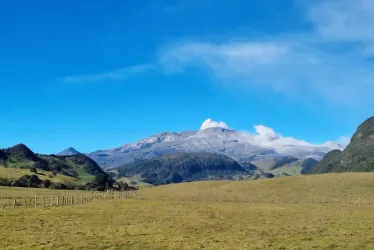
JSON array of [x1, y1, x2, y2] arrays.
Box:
[[0, 0, 374, 153]]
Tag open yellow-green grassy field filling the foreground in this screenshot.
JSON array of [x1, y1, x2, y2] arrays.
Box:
[[0, 173, 374, 249]]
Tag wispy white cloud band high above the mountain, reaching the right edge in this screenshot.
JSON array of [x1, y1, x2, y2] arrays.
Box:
[[160, 40, 374, 108]]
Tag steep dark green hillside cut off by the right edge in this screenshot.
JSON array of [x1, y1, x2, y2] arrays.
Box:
[[310, 117, 374, 173]]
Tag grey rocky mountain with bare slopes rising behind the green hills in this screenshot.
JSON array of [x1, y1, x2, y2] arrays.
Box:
[[88, 127, 344, 168]]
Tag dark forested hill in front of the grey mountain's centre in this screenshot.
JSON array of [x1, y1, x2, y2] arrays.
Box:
[[114, 153, 250, 185]]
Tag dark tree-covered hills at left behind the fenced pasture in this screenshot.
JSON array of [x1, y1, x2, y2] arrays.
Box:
[[0, 144, 108, 183]]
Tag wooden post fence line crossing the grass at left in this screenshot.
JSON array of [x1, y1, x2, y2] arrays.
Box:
[[0, 190, 136, 212]]
